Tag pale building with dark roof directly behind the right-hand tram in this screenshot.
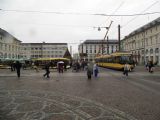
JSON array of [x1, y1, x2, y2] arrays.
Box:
[[78, 40, 118, 61]]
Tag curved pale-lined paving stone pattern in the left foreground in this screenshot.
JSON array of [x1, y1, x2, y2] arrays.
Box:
[[0, 90, 136, 120]]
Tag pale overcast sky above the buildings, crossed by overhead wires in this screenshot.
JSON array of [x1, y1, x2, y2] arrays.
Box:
[[0, 0, 160, 52]]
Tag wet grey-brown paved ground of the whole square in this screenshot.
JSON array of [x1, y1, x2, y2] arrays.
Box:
[[0, 66, 160, 120]]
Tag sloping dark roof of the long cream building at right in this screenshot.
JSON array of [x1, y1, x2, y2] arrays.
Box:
[[124, 17, 160, 39]]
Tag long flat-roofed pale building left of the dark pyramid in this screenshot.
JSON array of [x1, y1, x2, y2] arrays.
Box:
[[21, 42, 68, 59]]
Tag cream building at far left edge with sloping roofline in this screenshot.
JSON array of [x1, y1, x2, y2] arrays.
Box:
[[0, 28, 21, 60]]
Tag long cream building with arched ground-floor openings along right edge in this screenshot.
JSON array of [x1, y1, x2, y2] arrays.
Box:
[[121, 17, 160, 65]]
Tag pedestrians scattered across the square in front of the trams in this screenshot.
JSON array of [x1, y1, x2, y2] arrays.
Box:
[[8, 60, 158, 79]]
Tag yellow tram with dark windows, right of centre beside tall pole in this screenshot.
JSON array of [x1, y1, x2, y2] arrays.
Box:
[[95, 52, 134, 70]]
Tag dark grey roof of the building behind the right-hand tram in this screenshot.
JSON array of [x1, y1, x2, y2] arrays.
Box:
[[83, 39, 118, 44]]
